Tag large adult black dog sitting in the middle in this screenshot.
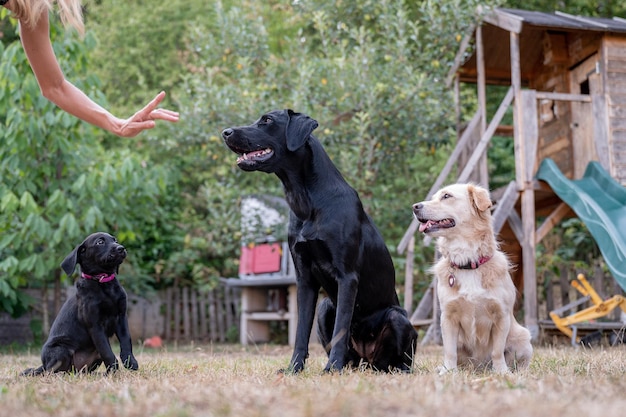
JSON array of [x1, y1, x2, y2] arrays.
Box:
[[222, 110, 417, 372]]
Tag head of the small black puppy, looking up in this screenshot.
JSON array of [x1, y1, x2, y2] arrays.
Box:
[[61, 232, 126, 276]]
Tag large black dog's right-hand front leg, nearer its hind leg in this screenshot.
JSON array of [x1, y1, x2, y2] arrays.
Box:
[[324, 272, 359, 372]]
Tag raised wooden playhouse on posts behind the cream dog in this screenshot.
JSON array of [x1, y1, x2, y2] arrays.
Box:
[[398, 9, 626, 339]]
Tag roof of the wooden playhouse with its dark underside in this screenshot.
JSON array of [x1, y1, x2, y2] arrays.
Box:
[[451, 8, 626, 85]]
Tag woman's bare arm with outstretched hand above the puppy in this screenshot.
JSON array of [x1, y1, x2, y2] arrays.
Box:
[[20, 14, 178, 137]]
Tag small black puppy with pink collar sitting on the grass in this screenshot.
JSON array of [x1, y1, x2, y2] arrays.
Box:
[[22, 233, 139, 375]]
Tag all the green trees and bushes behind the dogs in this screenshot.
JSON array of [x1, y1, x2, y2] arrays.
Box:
[[8, 0, 619, 306]]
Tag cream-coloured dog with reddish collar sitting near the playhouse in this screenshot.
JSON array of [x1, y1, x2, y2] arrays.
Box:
[[413, 184, 533, 373]]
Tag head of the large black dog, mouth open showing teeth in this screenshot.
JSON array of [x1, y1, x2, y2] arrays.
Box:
[[222, 109, 318, 172]]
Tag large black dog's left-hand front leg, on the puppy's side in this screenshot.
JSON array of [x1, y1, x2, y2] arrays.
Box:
[[287, 276, 319, 373]]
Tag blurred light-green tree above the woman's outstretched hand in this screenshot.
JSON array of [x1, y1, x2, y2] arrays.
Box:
[[85, 0, 213, 115]]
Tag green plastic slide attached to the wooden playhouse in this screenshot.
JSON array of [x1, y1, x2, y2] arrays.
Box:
[[536, 158, 626, 291]]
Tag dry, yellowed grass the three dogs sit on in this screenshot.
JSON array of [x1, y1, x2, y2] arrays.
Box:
[[0, 345, 626, 417]]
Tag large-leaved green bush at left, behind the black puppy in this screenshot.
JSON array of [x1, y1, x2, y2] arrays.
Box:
[[0, 17, 166, 314]]
